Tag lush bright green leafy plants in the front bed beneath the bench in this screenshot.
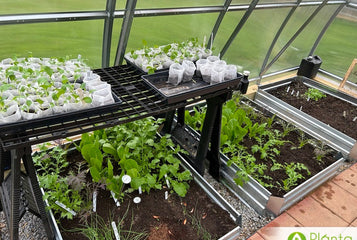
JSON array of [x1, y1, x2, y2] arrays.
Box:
[[78, 117, 191, 201]]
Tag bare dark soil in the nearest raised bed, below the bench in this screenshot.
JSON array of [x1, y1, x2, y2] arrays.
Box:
[[57, 152, 237, 240]]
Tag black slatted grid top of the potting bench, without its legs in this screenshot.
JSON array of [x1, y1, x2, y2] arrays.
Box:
[[0, 65, 239, 151]]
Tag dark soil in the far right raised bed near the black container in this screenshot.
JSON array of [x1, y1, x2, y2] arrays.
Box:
[[269, 80, 357, 139]]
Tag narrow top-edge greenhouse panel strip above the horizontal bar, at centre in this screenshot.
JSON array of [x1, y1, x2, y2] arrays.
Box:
[[116, 0, 225, 9]]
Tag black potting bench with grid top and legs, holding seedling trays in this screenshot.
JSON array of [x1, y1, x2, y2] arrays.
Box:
[[0, 65, 240, 240]]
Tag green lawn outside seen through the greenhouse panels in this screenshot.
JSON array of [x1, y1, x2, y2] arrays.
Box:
[[0, 0, 357, 77]]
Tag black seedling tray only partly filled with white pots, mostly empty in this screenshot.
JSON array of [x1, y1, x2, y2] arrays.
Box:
[[142, 70, 243, 104]]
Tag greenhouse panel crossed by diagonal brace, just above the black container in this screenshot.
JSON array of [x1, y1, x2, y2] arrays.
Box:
[[266, 6, 326, 73]]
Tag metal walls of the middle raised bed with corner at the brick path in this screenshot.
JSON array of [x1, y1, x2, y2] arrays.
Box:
[[178, 99, 345, 215]]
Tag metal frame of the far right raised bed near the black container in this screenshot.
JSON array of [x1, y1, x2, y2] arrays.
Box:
[[255, 76, 357, 157]]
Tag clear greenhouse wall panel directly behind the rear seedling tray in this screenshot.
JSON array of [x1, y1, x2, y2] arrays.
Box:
[[122, 13, 218, 52]]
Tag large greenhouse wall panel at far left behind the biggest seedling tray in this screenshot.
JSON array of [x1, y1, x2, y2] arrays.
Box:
[[0, 20, 103, 68]]
